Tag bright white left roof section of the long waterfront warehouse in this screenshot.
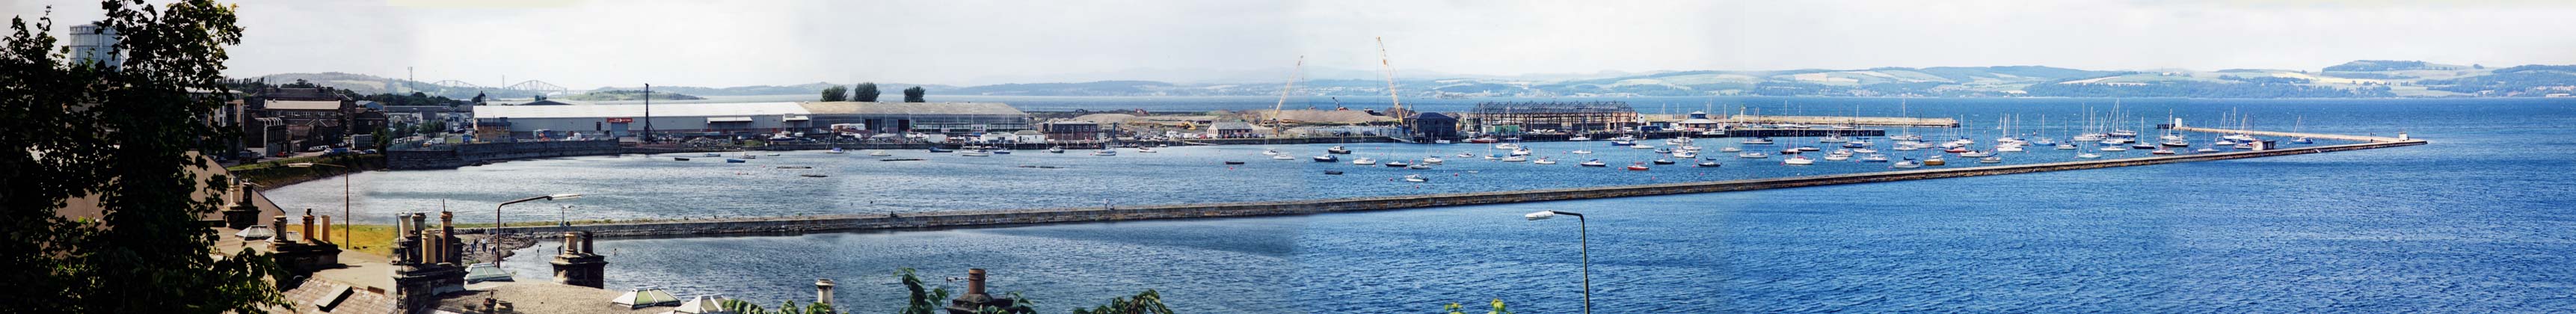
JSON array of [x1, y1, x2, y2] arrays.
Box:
[[474, 103, 806, 118]]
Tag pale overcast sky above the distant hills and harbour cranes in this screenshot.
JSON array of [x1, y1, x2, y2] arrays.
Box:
[[0, 0, 2576, 90]]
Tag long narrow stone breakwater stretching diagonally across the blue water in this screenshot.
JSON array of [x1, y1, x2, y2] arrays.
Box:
[[473, 132, 2426, 237]]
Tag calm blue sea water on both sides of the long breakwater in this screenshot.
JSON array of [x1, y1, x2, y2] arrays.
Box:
[[306, 98, 2576, 314]]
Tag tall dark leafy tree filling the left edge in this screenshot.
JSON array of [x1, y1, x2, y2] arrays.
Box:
[[0, 0, 289, 314]]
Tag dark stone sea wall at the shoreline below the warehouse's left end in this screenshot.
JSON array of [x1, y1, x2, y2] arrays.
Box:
[[384, 141, 624, 170]]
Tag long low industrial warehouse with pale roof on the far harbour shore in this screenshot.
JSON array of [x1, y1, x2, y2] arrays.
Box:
[[474, 100, 1030, 139]]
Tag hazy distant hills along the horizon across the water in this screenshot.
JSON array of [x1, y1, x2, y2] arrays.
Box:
[[245, 59, 2576, 98]]
